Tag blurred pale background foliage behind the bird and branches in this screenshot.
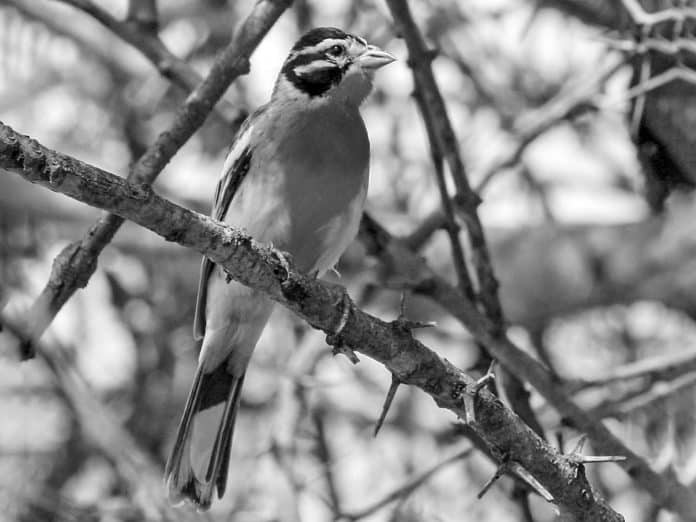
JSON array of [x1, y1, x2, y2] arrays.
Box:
[[0, 0, 696, 521]]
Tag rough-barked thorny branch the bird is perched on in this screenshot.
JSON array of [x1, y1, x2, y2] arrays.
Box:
[[0, 125, 623, 521]]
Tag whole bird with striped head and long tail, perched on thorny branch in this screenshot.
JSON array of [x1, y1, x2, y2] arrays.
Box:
[[165, 27, 396, 511]]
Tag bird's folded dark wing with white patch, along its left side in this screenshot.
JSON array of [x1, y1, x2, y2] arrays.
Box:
[[193, 107, 265, 340]]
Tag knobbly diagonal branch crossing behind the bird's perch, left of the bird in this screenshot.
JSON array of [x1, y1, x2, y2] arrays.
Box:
[[29, 0, 290, 338]]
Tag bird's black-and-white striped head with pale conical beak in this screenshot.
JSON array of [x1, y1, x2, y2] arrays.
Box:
[[273, 27, 396, 106]]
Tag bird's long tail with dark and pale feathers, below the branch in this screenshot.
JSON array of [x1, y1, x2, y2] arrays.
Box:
[[164, 361, 244, 510]]
